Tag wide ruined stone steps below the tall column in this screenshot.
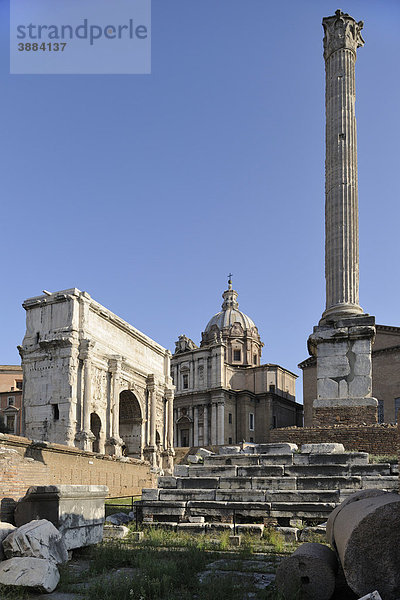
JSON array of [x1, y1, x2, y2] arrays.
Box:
[[138, 444, 398, 531]]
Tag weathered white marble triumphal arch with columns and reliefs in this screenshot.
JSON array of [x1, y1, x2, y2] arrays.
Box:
[[19, 288, 174, 468]]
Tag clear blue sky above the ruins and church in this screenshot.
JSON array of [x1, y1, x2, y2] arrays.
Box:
[[0, 0, 400, 404]]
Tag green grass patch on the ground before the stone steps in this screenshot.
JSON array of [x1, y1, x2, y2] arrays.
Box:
[[55, 528, 293, 600]]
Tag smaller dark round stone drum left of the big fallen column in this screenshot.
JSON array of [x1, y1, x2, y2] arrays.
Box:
[[275, 543, 338, 600]]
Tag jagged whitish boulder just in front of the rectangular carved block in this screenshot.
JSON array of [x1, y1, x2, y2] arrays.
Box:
[[3, 519, 68, 564]]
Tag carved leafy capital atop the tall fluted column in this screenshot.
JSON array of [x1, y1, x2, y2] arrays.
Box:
[[322, 10, 364, 60]]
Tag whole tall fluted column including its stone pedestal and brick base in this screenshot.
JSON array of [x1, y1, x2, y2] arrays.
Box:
[[308, 10, 377, 425]]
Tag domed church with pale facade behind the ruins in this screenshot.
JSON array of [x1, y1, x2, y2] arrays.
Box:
[[171, 279, 303, 446]]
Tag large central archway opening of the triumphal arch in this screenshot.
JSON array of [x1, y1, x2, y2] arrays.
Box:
[[119, 390, 143, 458]]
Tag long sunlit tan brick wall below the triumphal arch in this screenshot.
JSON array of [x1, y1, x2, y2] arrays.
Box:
[[0, 434, 156, 521]]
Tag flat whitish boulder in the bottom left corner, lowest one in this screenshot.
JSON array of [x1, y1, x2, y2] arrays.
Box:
[[0, 557, 60, 593]]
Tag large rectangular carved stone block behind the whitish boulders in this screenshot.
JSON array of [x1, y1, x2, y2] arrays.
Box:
[[15, 485, 108, 550]]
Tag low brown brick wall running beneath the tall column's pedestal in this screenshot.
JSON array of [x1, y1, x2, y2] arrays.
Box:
[[270, 424, 399, 455]]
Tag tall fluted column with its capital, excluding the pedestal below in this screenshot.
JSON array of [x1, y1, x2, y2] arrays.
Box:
[[322, 10, 364, 319]]
